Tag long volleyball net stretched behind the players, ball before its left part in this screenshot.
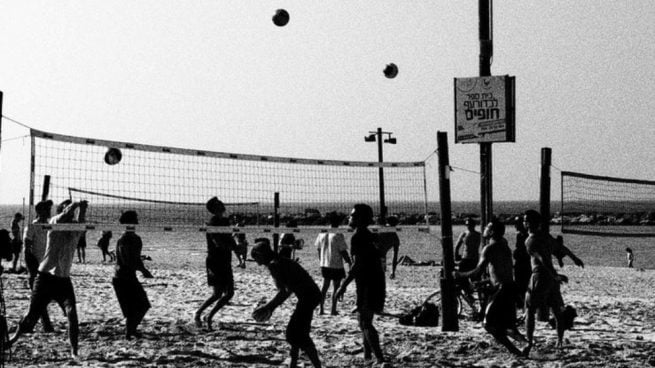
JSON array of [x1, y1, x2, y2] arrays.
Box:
[[29, 129, 434, 232]]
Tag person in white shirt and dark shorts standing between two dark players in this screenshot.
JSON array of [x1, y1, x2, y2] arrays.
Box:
[[314, 212, 351, 316]]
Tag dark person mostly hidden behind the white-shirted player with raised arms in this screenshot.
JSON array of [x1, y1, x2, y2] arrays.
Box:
[[23, 200, 54, 332]]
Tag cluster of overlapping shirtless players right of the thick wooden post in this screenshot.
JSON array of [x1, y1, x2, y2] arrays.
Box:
[[453, 210, 584, 357]]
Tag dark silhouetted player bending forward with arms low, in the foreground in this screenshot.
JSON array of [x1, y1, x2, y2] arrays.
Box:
[[250, 238, 321, 368]]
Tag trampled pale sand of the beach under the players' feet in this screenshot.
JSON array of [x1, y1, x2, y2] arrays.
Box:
[[2, 229, 655, 368]]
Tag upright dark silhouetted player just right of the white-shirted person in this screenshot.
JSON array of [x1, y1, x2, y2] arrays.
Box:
[[336, 204, 388, 367]]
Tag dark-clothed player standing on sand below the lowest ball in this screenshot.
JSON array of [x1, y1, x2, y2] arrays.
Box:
[[112, 211, 152, 340]]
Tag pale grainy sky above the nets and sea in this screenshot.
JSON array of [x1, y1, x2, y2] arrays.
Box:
[[0, 0, 655, 203]]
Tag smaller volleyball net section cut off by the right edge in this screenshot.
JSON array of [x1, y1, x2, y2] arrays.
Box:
[[561, 171, 655, 237]]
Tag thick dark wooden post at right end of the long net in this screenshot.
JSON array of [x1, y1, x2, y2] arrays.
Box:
[[437, 132, 459, 331]]
